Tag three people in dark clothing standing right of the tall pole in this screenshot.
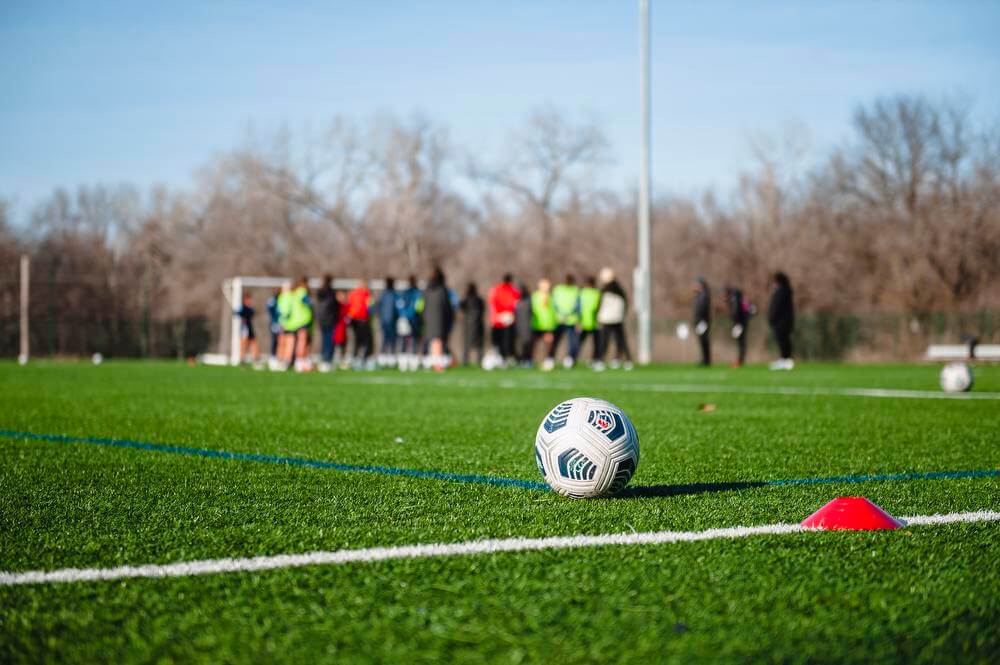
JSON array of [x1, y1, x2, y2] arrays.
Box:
[[685, 272, 795, 370]]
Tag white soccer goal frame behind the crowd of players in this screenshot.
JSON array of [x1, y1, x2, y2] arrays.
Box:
[[219, 275, 385, 365]]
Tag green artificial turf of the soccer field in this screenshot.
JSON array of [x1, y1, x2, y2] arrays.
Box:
[[0, 361, 1000, 663]]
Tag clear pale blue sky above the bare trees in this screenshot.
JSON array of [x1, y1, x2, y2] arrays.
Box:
[[0, 0, 1000, 214]]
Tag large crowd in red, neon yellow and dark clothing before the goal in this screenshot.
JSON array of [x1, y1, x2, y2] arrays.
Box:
[[235, 268, 632, 372]]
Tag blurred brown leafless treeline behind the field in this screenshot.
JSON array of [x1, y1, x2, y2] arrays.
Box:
[[0, 96, 1000, 355]]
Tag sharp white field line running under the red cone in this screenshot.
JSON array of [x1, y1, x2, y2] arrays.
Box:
[[0, 511, 1000, 586]]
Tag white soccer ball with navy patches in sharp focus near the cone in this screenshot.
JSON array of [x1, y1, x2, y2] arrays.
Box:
[[535, 397, 639, 499]]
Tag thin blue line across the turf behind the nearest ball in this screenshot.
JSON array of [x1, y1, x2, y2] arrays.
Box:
[[0, 430, 1000, 496]]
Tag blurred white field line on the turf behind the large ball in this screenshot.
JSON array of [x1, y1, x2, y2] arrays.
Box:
[[328, 376, 1000, 400]]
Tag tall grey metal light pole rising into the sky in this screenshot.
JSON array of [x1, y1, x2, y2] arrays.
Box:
[[635, 0, 653, 365]]
